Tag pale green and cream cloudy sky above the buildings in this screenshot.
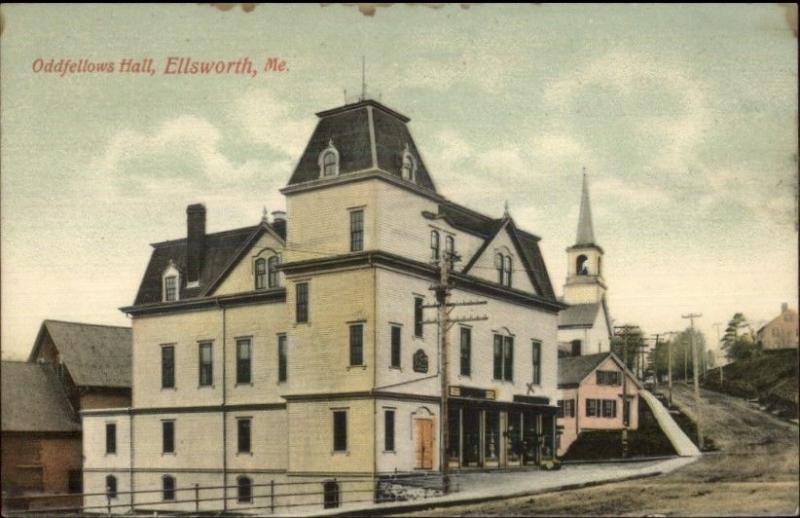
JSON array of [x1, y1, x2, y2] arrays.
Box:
[[0, 4, 798, 359]]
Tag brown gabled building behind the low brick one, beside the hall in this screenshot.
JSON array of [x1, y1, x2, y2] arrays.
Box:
[[28, 320, 132, 411]]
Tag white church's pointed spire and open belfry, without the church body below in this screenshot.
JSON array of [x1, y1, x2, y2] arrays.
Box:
[[564, 169, 606, 304]]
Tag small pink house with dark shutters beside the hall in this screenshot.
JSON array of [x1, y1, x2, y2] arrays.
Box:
[[558, 352, 642, 456]]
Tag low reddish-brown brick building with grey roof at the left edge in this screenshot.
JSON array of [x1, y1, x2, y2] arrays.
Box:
[[2, 361, 81, 504]]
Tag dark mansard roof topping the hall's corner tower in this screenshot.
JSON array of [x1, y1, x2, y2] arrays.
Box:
[[289, 100, 436, 192]]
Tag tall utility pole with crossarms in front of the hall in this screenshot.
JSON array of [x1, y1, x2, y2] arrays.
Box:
[[422, 250, 489, 494]]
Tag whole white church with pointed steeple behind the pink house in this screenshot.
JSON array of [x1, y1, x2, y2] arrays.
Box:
[[558, 174, 613, 356]]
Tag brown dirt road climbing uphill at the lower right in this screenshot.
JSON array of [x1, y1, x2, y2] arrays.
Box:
[[417, 384, 800, 516]]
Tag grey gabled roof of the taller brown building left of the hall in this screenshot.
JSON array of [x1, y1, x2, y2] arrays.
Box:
[[29, 320, 133, 388]]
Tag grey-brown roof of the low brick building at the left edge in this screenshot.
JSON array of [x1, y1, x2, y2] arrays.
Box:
[[0, 361, 81, 432]]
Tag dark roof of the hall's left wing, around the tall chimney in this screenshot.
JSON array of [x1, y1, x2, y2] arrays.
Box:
[[134, 222, 286, 306]]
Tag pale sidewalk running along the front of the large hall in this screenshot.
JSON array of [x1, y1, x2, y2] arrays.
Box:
[[304, 457, 699, 516]]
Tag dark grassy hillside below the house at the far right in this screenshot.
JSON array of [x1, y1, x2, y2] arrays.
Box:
[[703, 349, 798, 417]]
